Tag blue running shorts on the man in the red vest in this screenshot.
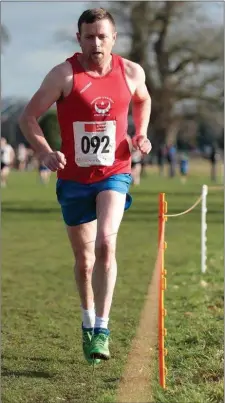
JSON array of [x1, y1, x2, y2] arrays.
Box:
[[56, 174, 132, 226]]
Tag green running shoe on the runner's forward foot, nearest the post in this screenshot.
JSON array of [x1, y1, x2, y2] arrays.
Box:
[[90, 328, 110, 360]]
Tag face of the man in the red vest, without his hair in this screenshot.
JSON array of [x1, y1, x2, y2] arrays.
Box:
[[77, 20, 116, 65]]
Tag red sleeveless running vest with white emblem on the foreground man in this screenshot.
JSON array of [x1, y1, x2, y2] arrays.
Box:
[[57, 53, 131, 183]]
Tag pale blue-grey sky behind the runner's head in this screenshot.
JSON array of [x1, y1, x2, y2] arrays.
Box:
[[1, 1, 223, 98]]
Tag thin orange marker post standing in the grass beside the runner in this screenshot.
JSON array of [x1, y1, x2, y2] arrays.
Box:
[[158, 193, 167, 389]]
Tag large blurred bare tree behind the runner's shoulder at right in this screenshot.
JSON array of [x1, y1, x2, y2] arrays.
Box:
[[109, 1, 224, 146]]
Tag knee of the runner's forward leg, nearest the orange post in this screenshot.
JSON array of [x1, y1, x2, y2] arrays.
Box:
[[95, 237, 116, 269]]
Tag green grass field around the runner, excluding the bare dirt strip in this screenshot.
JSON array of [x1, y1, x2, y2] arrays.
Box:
[[2, 172, 223, 403]]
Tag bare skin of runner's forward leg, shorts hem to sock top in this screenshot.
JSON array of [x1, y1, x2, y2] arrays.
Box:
[[92, 190, 126, 327]]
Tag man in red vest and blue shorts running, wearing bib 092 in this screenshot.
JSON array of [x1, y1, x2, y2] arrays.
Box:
[[20, 8, 151, 363]]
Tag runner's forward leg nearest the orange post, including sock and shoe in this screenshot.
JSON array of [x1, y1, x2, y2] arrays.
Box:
[[90, 190, 126, 360]]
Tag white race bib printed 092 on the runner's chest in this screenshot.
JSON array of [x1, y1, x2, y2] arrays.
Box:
[[73, 120, 116, 167]]
